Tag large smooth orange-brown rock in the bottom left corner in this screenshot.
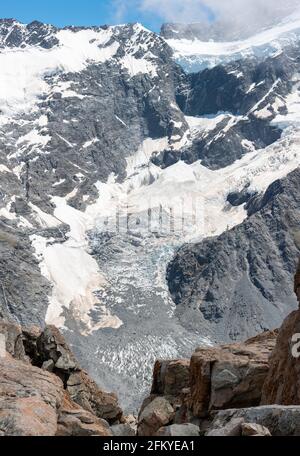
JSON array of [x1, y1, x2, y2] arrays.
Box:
[[0, 355, 63, 436]]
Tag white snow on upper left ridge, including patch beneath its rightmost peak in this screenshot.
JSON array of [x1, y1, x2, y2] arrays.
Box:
[[0, 22, 166, 117]]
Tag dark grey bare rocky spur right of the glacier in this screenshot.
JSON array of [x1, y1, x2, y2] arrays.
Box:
[[168, 169, 300, 341]]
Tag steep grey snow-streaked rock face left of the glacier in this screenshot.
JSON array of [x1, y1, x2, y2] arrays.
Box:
[[0, 19, 187, 332]]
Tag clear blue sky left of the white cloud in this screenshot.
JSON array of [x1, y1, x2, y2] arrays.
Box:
[[0, 0, 166, 30]]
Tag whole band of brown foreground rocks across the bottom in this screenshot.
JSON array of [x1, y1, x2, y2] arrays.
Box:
[[0, 258, 300, 436]]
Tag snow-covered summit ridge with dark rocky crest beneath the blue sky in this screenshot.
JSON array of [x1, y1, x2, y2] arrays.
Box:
[[0, 19, 170, 117]]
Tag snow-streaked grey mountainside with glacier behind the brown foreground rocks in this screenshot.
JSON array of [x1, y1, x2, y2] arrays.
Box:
[[0, 19, 300, 410]]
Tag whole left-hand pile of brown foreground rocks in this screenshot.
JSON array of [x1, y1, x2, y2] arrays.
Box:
[[0, 321, 123, 436]]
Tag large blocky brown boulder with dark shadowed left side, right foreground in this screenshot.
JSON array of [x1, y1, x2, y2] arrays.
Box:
[[188, 331, 277, 417]]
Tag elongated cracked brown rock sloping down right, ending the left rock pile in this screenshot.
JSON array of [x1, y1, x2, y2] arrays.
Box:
[[67, 371, 123, 424]]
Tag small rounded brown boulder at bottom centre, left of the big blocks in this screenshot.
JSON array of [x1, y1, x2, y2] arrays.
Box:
[[138, 397, 175, 436]]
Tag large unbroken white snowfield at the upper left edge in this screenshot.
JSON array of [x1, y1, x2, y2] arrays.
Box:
[[0, 28, 119, 116]]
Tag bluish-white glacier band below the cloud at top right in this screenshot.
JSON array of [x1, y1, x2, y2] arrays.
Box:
[[166, 12, 300, 72]]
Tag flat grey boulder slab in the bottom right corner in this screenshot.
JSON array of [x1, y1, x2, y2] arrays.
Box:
[[206, 405, 300, 436]]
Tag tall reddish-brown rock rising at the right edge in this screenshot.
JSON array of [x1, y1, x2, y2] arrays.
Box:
[[261, 310, 300, 405]]
